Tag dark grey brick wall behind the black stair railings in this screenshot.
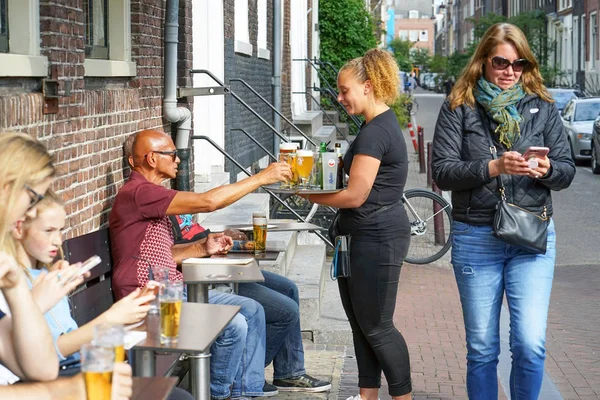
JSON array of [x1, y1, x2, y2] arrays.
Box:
[[223, 0, 273, 180]]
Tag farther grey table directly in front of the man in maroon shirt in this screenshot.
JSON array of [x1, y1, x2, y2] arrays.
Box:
[[181, 260, 265, 303]]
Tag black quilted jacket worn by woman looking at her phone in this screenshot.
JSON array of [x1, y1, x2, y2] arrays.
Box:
[[432, 95, 575, 225]]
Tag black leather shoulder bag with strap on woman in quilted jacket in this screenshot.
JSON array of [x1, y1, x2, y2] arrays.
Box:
[[479, 109, 550, 254]]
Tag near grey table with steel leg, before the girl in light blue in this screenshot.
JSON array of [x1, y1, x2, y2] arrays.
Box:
[[133, 302, 240, 400]]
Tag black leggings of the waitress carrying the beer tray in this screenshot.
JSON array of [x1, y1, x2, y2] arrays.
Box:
[[338, 238, 412, 396]]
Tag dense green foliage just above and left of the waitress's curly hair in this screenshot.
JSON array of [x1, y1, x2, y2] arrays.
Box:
[[319, 0, 377, 68]]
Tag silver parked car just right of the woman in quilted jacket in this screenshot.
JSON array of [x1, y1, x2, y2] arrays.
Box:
[[561, 97, 600, 161]]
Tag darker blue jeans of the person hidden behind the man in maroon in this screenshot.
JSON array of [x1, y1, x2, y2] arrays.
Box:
[[238, 271, 306, 379]]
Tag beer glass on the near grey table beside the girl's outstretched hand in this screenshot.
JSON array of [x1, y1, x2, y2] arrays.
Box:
[[158, 281, 183, 344]]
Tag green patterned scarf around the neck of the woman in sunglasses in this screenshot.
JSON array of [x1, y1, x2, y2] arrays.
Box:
[[473, 76, 525, 149]]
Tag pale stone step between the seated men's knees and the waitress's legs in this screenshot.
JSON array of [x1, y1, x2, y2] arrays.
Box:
[[288, 244, 329, 332]]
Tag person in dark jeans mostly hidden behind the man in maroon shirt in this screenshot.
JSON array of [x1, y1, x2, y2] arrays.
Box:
[[169, 214, 331, 393]]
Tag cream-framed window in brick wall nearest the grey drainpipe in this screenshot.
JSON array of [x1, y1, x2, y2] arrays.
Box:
[[83, 0, 136, 77]]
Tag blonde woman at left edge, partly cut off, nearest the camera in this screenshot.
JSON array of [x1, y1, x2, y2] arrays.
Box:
[[0, 132, 131, 400]]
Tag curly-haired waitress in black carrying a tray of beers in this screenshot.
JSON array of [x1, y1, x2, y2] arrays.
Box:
[[308, 49, 412, 400]]
